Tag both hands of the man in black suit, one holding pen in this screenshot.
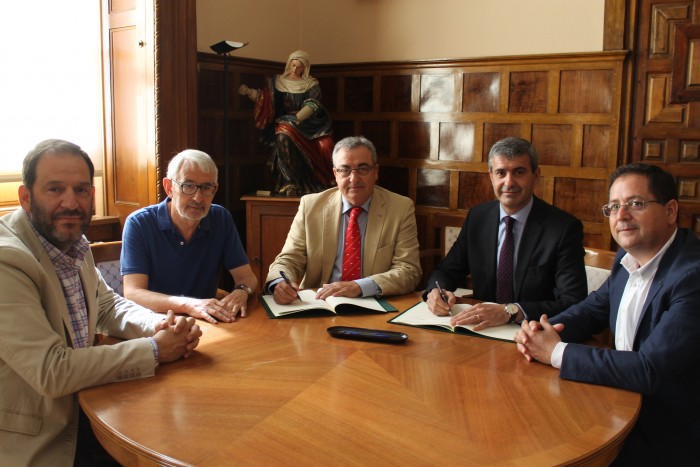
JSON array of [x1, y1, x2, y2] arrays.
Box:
[[426, 289, 509, 331]]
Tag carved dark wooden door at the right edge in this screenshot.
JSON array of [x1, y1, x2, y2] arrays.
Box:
[[630, 0, 700, 234]]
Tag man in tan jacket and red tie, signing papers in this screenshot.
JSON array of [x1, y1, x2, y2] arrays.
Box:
[[264, 136, 421, 304]]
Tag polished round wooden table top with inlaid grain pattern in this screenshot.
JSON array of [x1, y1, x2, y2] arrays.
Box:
[[79, 294, 641, 466]]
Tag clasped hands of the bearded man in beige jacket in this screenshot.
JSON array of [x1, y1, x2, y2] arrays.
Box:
[[153, 310, 202, 363]]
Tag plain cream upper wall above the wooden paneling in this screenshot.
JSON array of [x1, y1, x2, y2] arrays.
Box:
[[197, 0, 605, 63]]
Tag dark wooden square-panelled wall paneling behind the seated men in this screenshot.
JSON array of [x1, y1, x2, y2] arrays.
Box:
[[200, 51, 628, 284]]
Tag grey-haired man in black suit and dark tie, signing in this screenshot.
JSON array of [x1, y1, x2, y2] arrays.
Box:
[[423, 137, 588, 329]]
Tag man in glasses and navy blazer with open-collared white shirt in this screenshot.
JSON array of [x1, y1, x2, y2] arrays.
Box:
[[516, 163, 700, 466]]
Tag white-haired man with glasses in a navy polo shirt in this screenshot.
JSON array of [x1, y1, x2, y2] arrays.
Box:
[[121, 149, 258, 323]]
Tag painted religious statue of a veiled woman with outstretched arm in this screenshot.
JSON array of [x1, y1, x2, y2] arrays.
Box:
[[238, 50, 334, 196]]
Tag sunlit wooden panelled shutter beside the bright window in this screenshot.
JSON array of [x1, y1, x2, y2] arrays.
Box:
[[102, 0, 157, 225]]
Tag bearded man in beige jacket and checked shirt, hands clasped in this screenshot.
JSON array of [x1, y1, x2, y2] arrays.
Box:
[[0, 140, 201, 466]]
